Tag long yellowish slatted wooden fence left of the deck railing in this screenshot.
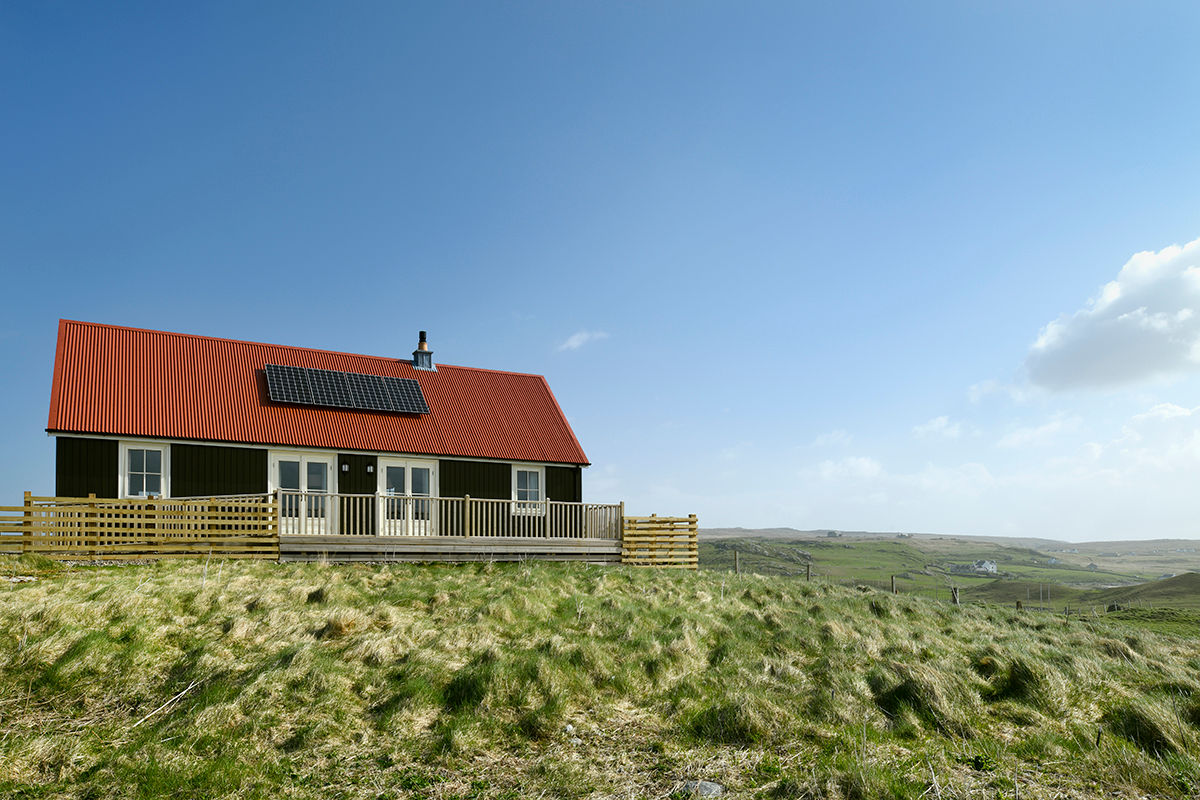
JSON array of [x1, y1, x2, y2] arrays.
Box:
[[0, 492, 280, 561]]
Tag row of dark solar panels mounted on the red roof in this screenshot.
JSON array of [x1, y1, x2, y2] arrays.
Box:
[[265, 363, 430, 414]]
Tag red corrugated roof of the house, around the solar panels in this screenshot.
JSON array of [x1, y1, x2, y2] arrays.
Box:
[[47, 319, 588, 464]]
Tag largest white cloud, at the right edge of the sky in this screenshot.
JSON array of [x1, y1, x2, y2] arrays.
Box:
[[1025, 239, 1200, 390]]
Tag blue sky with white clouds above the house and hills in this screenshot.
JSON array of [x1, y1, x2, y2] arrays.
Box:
[[0, 2, 1200, 540]]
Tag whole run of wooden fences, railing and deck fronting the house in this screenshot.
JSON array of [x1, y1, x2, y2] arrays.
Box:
[[0, 492, 697, 570]]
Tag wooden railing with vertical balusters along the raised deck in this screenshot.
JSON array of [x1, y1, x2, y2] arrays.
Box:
[[277, 489, 623, 540]]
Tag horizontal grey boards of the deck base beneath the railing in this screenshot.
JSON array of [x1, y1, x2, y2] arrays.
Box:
[[280, 534, 620, 564]]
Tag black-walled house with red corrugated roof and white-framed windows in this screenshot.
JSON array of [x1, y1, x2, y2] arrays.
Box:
[[46, 320, 619, 556]]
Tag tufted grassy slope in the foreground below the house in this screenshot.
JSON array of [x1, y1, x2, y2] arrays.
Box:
[[0, 559, 1200, 800]]
